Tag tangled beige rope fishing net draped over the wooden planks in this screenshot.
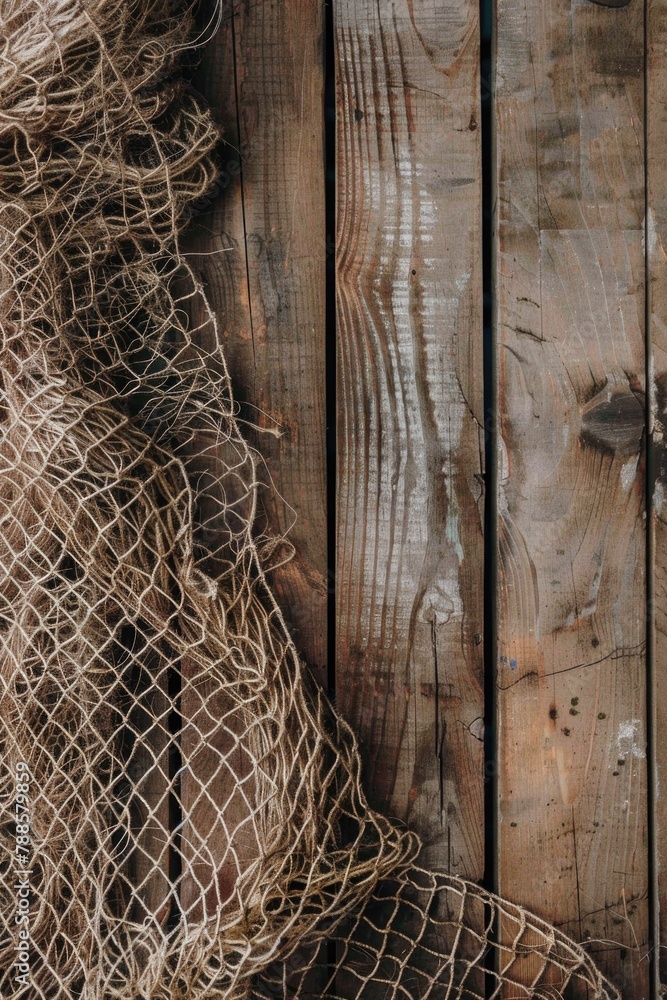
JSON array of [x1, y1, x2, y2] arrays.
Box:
[[0, 0, 620, 1000]]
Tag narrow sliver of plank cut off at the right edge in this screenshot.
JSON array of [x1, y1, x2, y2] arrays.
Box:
[[646, 0, 667, 983]]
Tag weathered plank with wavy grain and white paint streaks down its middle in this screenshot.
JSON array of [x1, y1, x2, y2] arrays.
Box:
[[335, 0, 484, 878]]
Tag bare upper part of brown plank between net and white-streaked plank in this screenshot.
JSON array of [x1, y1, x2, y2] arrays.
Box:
[[187, 0, 327, 683]]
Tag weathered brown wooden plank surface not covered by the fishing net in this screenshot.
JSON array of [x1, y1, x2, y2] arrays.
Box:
[[192, 0, 667, 998]]
